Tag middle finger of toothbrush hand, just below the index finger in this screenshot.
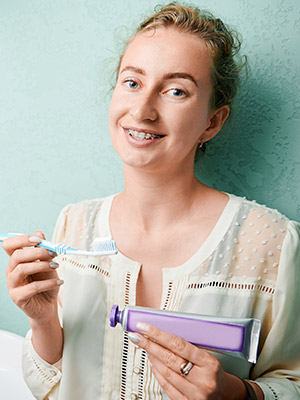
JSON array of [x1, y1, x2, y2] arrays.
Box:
[[7, 247, 56, 273]]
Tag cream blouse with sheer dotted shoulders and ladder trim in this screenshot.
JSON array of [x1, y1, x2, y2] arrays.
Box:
[[23, 195, 300, 400]]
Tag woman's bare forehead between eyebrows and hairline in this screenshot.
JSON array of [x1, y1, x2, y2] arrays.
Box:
[[120, 27, 212, 82]]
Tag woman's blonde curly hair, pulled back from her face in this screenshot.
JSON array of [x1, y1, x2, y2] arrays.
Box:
[[118, 2, 246, 109]]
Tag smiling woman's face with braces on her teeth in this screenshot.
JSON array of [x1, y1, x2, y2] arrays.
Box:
[[109, 27, 221, 171]]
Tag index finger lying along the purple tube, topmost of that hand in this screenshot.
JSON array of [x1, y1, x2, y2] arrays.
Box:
[[136, 322, 216, 367]]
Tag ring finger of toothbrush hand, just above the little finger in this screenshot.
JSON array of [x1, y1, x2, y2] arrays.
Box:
[[7, 261, 59, 288]]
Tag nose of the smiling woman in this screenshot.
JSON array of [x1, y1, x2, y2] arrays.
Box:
[[130, 93, 158, 122]]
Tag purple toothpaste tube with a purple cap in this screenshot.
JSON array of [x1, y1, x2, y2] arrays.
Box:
[[109, 305, 261, 363]]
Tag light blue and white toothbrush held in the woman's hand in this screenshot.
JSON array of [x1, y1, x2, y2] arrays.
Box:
[[0, 233, 118, 256]]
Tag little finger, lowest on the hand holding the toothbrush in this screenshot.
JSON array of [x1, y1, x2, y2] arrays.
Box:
[[10, 279, 64, 307]]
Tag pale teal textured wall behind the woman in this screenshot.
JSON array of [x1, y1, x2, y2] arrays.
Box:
[[0, 0, 300, 335]]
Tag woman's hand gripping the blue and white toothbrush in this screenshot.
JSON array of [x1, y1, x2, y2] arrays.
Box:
[[3, 231, 63, 323]]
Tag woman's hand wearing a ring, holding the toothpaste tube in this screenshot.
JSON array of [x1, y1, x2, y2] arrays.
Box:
[[129, 323, 247, 400]]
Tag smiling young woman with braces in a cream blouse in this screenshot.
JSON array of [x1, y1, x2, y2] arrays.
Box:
[[4, 5, 300, 400]]
